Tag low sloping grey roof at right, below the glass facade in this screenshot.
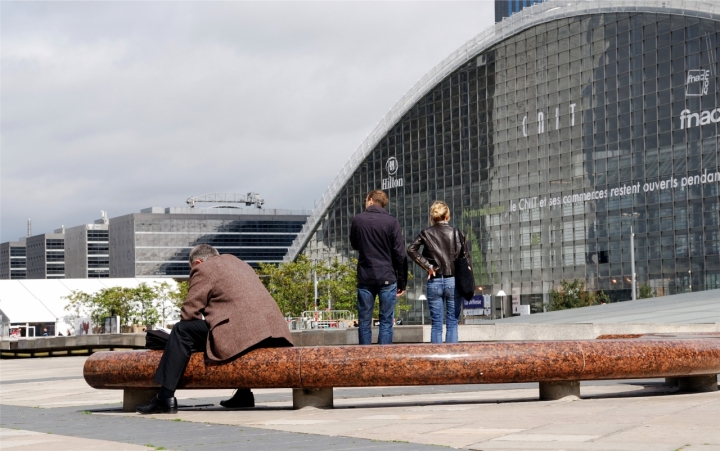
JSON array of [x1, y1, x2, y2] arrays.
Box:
[[493, 290, 720, 324]]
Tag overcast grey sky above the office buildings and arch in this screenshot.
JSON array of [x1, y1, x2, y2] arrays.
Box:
[[0, 1, 494, 242]]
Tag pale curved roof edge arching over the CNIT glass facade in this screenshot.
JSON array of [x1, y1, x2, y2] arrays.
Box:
[[284, 0, 720, 261]]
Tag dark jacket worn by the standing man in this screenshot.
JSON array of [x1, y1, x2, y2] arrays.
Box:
[[350, 205, 408, 290]]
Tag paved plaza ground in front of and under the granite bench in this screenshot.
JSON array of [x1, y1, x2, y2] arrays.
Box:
[[0, 357, 720, 451]]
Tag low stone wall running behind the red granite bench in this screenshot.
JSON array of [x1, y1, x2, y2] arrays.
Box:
[[0, 323, 720, 358]]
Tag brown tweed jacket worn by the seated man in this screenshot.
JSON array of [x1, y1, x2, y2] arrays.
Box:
[[181, 254, 292, 361]]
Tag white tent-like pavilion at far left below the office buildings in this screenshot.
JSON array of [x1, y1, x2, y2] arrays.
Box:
[[0, 278, 179, 323]]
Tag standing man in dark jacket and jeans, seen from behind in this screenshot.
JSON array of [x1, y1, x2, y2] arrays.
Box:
[[350, 190, 408, 345]]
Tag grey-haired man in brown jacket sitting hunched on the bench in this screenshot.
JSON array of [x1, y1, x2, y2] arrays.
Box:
[[137, 244, 293, 414]]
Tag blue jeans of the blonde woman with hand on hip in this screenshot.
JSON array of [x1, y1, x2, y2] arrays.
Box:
[[427, 276, 462, 343]]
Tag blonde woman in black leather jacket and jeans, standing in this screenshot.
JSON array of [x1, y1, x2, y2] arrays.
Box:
[[408, 200, 465, 343]]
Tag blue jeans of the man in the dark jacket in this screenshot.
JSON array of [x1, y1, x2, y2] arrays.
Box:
[[358, 283, 397, 345]]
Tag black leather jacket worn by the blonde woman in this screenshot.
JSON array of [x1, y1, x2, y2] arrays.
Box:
[[408, 222, 467, 276]]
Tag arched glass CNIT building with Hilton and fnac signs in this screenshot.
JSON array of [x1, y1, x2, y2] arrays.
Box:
[[286, 0, 720, 322]]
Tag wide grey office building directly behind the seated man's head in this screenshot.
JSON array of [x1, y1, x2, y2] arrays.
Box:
[[108, 207, 309, 278]]
